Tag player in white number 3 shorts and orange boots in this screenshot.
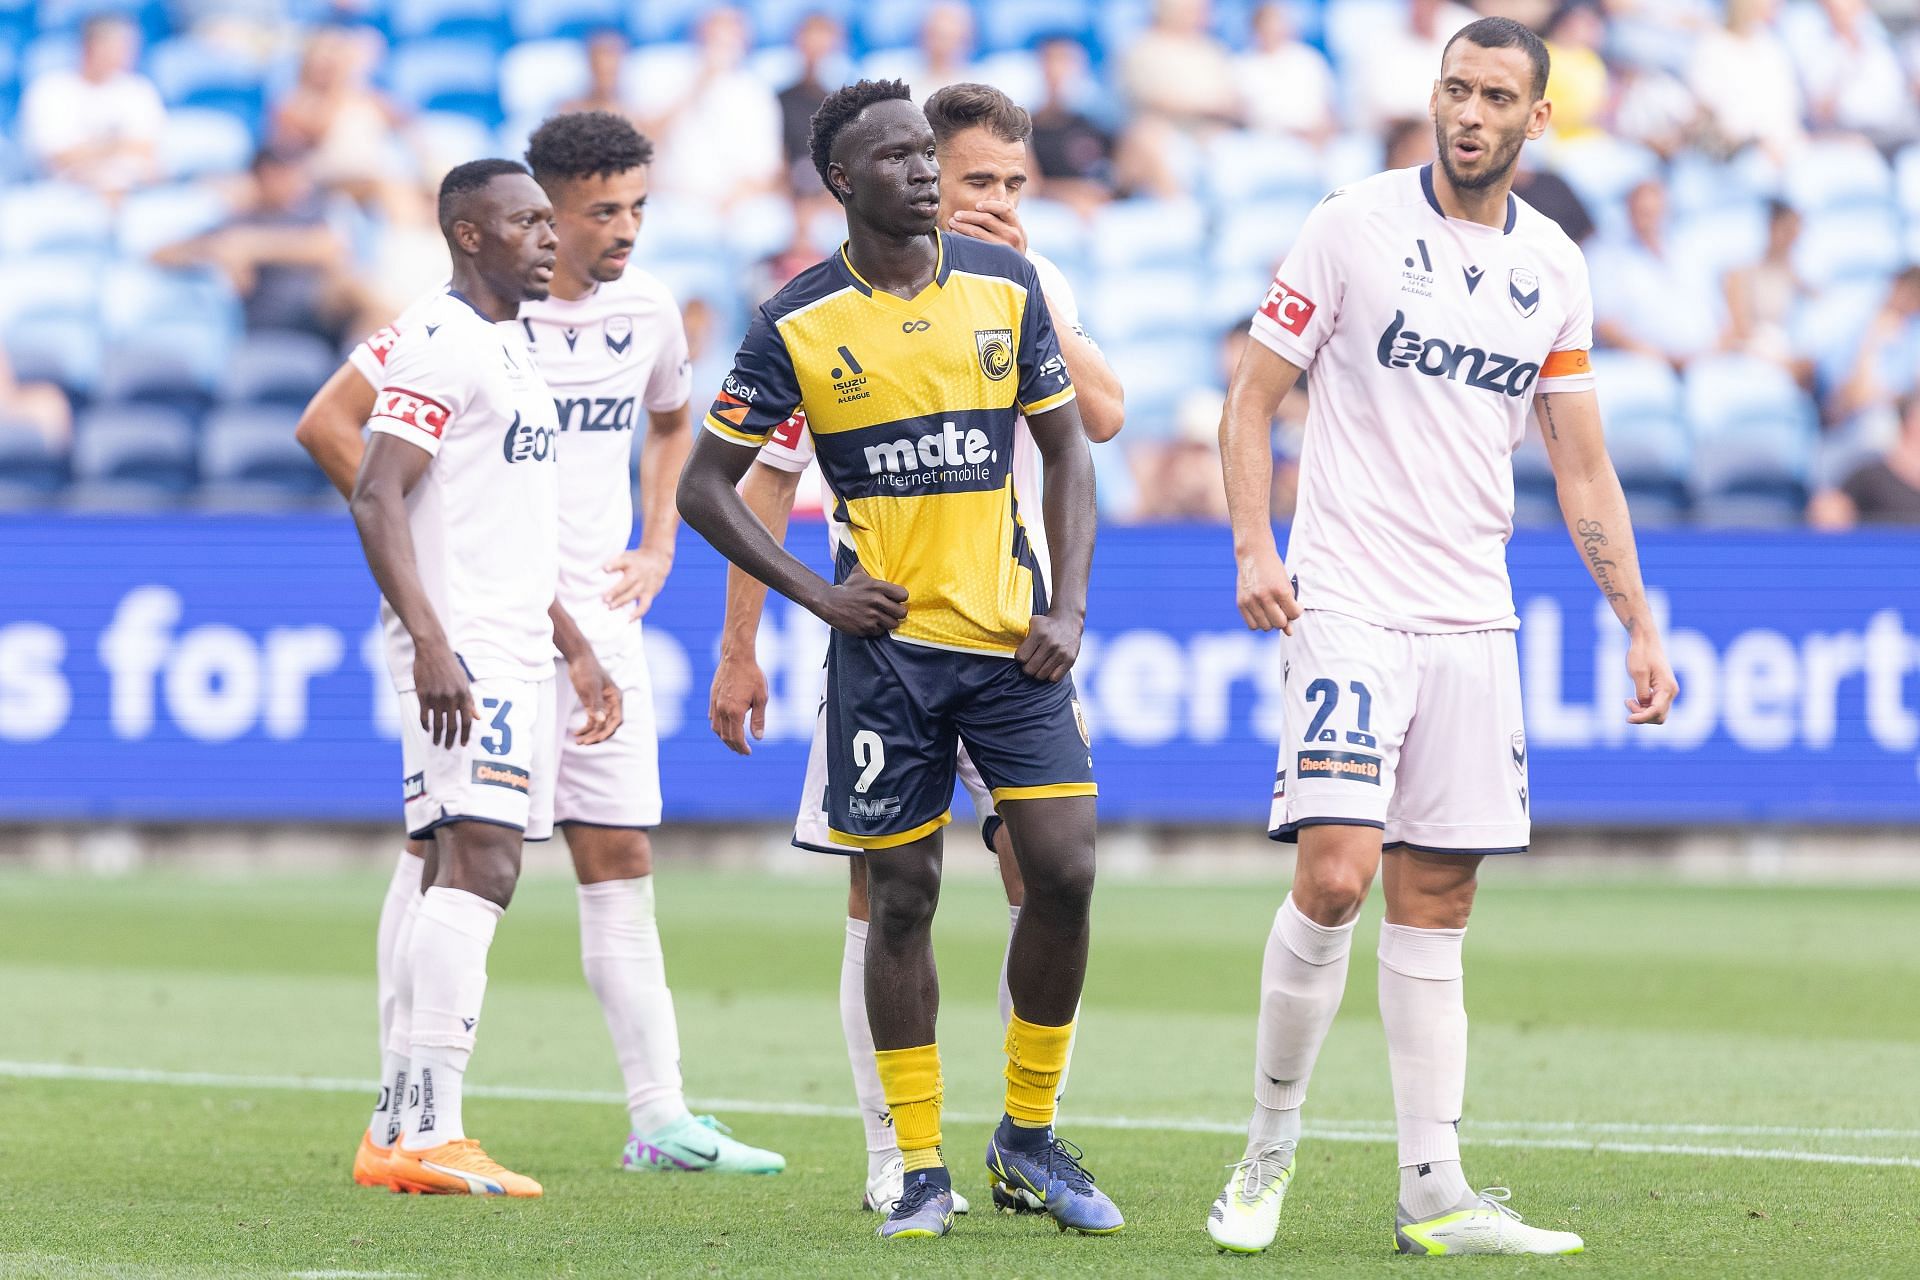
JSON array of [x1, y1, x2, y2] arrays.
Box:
[[351, 159, 602, 1196]]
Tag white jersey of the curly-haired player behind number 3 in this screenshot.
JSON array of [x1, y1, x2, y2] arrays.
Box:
[[520, 267, 693, 654]]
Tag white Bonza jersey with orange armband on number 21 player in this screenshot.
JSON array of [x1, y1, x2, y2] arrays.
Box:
[[1252, 167, 1594, 631]]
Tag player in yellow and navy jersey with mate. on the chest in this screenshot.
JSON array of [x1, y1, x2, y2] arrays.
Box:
[[680, 81, 1121, 1240]]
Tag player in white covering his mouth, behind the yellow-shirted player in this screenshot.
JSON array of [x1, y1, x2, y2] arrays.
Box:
[[708, 84, 1125, 1213]]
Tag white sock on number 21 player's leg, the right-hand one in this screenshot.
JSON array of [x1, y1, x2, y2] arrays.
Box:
[[1380, 925, 1471, 1222]]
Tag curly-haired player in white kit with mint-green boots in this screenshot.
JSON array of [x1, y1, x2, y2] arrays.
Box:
[[301, 111, 785, 1182]]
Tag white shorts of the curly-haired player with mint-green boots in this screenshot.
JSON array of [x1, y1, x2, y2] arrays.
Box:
[[553, 631, 660, 827]]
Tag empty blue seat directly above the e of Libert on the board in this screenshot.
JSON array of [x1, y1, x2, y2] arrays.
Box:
[[1686, 355, 1818, 524]]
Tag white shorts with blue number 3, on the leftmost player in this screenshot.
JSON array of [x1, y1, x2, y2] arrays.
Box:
[[399, 677, 553, 841]]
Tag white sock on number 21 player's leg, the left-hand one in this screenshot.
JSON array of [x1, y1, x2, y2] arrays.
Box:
[[1246, 894, 1354, 1157]]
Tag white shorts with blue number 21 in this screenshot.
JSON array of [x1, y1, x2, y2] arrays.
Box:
[[1267, 610, 1530, 854]]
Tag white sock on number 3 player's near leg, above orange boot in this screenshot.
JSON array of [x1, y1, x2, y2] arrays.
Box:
[[403, 885, 505, 1151]]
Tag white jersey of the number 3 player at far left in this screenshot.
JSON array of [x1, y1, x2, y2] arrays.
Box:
[[367, 292, 559, 693]]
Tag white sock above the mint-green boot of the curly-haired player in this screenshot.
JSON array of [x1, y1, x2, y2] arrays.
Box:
[[580, 875, 687, 1136]]
